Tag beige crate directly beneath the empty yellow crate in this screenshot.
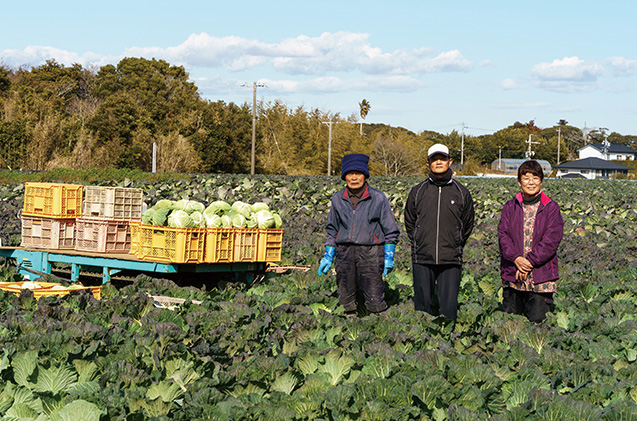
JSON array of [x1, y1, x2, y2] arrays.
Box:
[[20, 215, 76, 249]]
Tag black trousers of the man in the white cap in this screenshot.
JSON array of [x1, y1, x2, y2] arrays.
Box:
[[413, 264, 462, 320]]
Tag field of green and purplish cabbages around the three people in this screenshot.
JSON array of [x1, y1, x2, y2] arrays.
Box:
[[0, 175, 637, 420]]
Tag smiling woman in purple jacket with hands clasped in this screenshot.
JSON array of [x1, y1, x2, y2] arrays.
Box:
[[498, 160, 564, 323]]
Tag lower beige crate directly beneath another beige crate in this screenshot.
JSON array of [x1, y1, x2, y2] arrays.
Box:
[[75, 217, 131, 253]]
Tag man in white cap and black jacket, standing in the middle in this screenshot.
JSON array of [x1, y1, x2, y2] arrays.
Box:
[[405, 144, 474, 320]]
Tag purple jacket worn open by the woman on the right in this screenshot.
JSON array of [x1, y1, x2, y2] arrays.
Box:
[[498, 192, 564, 284]]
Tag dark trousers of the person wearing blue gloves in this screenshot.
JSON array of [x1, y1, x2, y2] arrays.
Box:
[[334, 245, 387, 313]]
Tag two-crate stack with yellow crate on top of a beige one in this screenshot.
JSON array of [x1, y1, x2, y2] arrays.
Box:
[[20, 183, 84, 249]]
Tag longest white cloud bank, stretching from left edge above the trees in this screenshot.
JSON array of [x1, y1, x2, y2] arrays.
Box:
[[2, 32, 475, 75]]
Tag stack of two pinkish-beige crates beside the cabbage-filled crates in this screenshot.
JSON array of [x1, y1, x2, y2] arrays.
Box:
[[75, 186, 144, 253]]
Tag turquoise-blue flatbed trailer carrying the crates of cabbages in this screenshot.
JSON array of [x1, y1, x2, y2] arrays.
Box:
[[0, 247, 267, 284]]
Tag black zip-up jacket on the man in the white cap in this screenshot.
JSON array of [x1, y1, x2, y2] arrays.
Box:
[[405, 178, 475, 265]]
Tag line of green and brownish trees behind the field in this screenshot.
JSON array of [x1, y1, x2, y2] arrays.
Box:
[[0, 58, 637, 176]]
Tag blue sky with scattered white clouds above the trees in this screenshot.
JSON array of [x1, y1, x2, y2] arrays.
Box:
[[0, 0, 637, 135]]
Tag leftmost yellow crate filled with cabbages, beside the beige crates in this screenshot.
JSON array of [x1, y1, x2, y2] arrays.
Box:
[[137, 225, 206, 263]]
